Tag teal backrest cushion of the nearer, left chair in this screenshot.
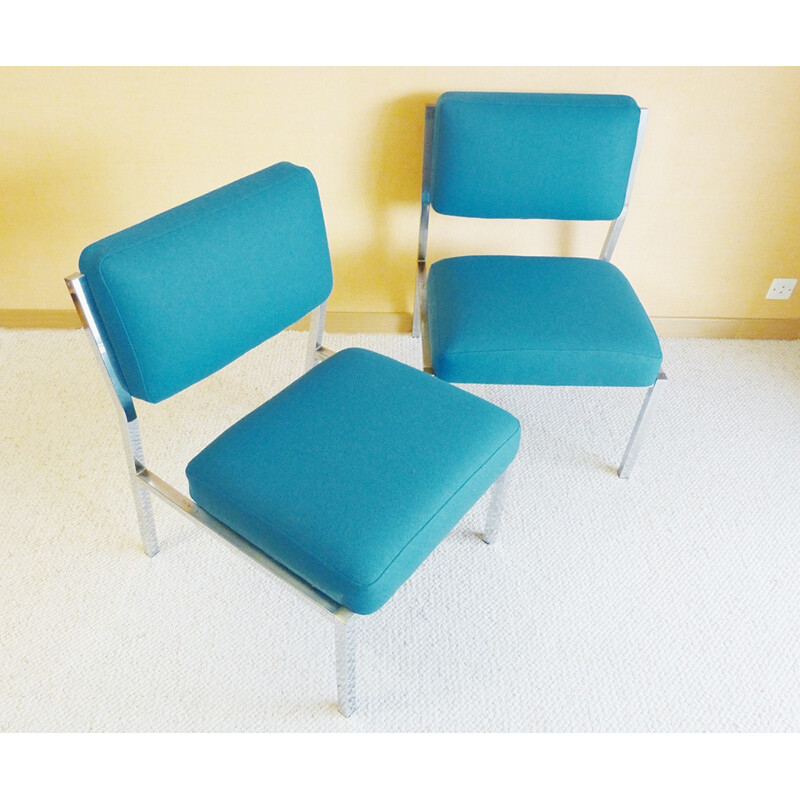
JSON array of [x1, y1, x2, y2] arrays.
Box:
[[80, 162, 333, 403]]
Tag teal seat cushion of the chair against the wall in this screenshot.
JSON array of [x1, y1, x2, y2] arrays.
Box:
[[427, 256, 661, 386]]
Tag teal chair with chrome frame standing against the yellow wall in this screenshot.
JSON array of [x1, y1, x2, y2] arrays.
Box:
[[413, 92, 666, 478]]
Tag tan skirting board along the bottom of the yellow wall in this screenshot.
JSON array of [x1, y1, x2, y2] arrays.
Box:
[[0, 308, 800, 339]]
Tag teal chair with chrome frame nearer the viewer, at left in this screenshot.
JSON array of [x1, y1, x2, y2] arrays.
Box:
[[66, 163, 519, 716]]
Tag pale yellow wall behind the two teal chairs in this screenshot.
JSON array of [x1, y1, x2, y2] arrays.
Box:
[[0, 67, 800, 328]]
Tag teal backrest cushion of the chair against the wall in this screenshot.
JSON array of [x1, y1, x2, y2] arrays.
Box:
[[431, 92, 640, 220]]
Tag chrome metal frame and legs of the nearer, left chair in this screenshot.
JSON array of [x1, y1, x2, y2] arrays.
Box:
[[65, 273, 503, 717]]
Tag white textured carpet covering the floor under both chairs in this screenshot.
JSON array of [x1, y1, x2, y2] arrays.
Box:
[[0, 330, 800, 732]]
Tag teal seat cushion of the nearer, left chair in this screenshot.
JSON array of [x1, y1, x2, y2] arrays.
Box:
[[186, 348, 519, 614]]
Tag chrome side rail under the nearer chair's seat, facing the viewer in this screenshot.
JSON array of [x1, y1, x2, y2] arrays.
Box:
[[136, 461, 353, 622]]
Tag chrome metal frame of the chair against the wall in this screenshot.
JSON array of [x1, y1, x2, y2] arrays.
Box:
[[411, 98, 667, 479]]
